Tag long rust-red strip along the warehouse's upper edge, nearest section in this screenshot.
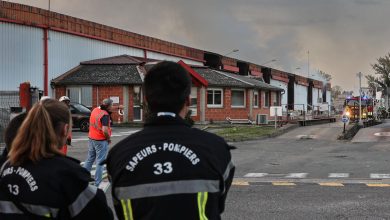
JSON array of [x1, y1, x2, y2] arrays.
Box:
[[0, 1, 203, 60]]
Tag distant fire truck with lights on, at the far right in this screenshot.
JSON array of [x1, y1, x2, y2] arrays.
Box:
[[344, 96, 374, 121]]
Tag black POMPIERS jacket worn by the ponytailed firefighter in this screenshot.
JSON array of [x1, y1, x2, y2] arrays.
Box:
[[0, 156, 113, 220]]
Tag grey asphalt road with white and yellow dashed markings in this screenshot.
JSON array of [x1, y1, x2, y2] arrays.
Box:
[[69, 123, 390, 219]]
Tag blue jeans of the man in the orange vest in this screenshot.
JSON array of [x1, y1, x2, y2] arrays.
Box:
[[84, 139, 108, 186]]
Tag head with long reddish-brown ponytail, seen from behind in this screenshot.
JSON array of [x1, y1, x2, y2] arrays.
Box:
[[8, 99, 71, 165]]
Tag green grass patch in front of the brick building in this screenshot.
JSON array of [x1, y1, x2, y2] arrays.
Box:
[[215, 126, 275, 141]]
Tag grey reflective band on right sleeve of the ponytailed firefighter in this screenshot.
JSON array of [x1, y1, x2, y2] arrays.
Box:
[[68, 185, 97, 218]]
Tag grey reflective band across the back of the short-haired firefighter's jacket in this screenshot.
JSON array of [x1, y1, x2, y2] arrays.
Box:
[[115, 180, 220, 199]]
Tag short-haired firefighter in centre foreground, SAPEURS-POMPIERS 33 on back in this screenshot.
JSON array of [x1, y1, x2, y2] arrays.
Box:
[[107, 61, 234, 220]]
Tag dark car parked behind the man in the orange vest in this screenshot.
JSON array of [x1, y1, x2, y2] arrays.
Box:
[[70, 102, 91, 132]]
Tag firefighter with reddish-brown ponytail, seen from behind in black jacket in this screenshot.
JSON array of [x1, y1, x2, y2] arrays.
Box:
[[0, 99, 113, 220]]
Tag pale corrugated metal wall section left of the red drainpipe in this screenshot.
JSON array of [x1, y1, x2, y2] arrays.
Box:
[[0, 22, 43, 91]]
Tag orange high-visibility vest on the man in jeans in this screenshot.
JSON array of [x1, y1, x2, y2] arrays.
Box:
[[88, 108, 111, 141]]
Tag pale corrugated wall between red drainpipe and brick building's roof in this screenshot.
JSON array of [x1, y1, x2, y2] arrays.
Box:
[[49, 31, 144, 95]]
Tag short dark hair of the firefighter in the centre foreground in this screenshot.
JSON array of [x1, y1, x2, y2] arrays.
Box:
[[144, 61, 191, 114]]
